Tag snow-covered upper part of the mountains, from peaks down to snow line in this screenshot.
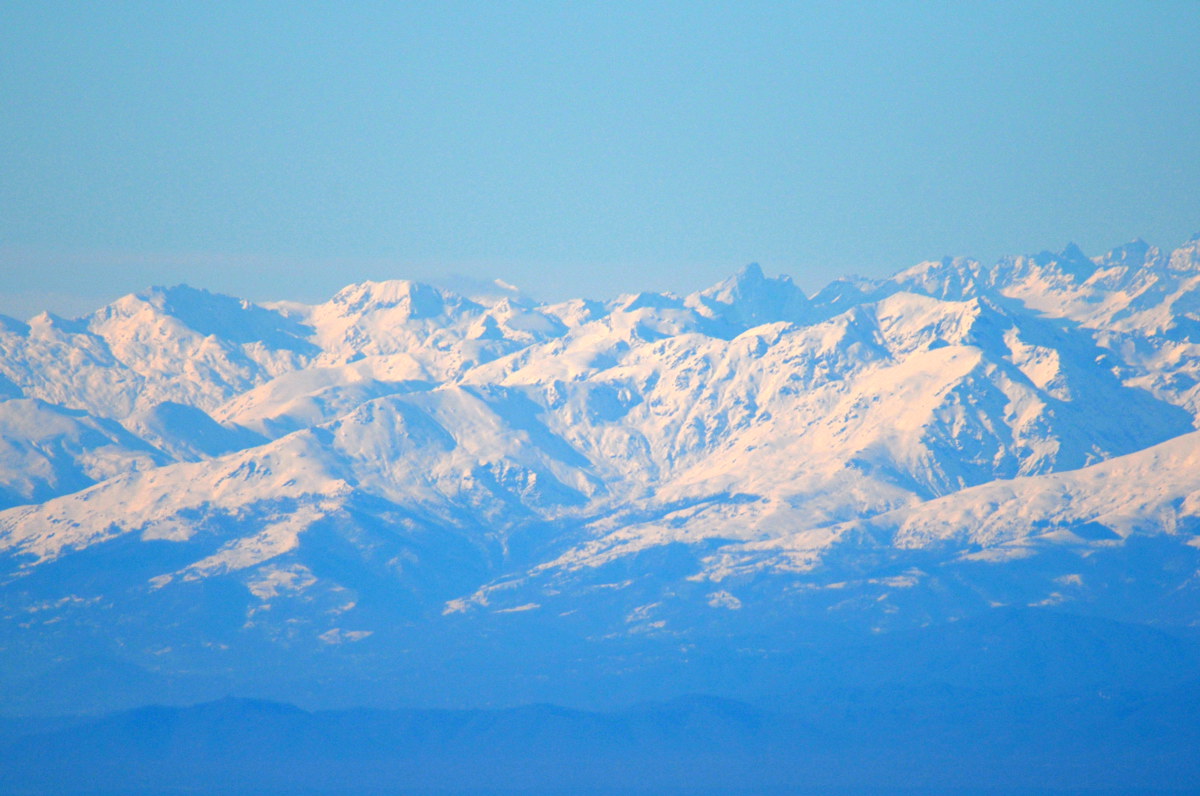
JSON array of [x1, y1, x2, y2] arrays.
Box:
[[0, 231, 1200, 653]]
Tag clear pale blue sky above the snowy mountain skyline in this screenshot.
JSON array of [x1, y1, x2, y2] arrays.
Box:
[[0, 0, 1200, 317]]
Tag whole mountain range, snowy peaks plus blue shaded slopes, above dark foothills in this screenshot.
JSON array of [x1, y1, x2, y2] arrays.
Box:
[[0, 239, 1200, 711]]
